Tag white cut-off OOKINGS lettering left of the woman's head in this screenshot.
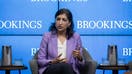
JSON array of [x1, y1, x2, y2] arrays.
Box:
[[0, 20, 42, 29]]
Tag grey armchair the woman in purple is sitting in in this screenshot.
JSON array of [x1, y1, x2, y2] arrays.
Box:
[[29, 48, 97, 74]]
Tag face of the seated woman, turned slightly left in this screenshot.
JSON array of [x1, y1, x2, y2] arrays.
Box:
[[55, 14, 71, 32]]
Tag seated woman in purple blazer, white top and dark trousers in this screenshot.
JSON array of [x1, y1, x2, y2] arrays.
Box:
[[38, 8, 84, 74]]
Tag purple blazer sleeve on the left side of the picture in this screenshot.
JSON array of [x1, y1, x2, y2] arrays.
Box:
[[37, 34, 51, 67]]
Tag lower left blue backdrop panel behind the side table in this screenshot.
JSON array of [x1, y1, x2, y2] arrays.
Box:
[[0, 36, 42, 74]]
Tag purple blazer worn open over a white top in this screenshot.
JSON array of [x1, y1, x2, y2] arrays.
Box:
[[37, 32, 84, 74]]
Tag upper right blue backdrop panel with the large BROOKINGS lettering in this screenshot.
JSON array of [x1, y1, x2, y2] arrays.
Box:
[[60, 0, 132, 35]]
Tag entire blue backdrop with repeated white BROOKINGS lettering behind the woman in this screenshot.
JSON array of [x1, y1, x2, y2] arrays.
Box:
[[0, 0, 132, 74]]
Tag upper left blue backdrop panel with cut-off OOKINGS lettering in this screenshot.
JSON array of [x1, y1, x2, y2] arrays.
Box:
[[0, 0, 58, 35]]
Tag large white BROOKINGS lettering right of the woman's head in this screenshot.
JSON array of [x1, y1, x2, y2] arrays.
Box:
[[77, 20, 132, 30]]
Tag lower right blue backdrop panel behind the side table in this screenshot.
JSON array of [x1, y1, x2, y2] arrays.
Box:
[[81, 36, 132, 74]]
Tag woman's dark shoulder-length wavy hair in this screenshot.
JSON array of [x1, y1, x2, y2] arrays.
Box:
[[49, 8, 74, 39]]
